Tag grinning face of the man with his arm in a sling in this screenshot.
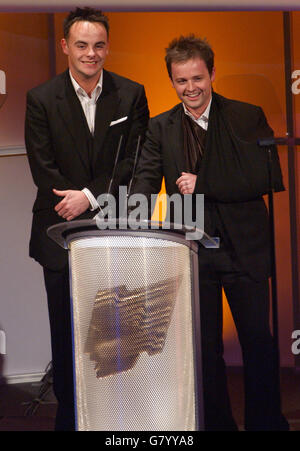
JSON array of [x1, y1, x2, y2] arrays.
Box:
[[171, 57, 215, 118]]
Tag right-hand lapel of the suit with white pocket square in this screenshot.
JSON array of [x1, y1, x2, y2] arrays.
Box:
[[93, 70, 120, 164]]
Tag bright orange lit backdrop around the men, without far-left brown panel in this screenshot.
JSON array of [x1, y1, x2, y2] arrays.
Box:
[[55, 12, 292, 364]]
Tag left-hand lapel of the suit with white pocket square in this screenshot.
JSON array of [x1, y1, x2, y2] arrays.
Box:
[[57, 72, 90, 173]]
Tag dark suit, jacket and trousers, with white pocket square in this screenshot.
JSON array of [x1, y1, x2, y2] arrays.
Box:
[[25, 70, 149, 430]]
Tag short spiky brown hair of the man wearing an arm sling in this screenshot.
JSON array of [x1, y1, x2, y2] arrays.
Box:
[[165, 34, 214, 79]]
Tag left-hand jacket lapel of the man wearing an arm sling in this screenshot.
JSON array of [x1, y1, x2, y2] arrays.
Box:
[[167, 104, 186, 177]]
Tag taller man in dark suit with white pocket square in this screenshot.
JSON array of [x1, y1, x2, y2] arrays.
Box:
[[25, 8, 149, 430]]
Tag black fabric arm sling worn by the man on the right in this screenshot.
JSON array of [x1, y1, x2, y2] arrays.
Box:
[[196, 93, 284, 202]]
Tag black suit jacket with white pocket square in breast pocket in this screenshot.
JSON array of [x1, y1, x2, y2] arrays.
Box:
[[25, 70, 149, 270]]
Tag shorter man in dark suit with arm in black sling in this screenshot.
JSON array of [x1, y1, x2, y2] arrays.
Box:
[[134, 35, 288, 431]]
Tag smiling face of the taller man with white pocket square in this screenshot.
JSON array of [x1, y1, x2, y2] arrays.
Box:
[[61, 21, 108, 84]]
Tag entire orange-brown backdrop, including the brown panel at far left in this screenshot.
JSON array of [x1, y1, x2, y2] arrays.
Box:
[[0, 12, 300, 366]]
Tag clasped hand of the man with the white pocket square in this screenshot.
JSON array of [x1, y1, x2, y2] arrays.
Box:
[[53, 189, 90, 221]]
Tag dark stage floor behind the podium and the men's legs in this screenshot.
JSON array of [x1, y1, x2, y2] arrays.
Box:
[[0, 367, 300, 431]]
